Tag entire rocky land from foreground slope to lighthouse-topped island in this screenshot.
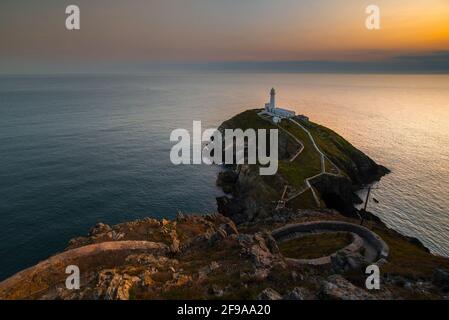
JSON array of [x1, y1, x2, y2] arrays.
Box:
[[0, 95, 449, 300]]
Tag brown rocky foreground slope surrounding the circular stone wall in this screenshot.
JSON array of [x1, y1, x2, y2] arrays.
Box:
[[0, 210, 449, 300]]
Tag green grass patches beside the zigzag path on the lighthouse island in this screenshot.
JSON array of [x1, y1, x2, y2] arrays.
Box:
[[218, 110, 372, 209]]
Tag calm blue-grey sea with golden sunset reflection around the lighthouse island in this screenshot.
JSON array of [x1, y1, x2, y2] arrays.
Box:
[[0, 72, 449, 279]]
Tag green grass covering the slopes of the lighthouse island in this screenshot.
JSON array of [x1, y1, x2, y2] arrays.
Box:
[[221, 109, 384, 209]]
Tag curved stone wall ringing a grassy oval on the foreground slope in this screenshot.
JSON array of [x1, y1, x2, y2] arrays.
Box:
[[271, 221, 390, 265]]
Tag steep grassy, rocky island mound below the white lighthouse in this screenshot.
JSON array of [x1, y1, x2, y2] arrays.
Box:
[[217, 110, 389, 223]]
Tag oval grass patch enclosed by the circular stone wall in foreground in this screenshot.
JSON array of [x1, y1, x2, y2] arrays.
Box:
[[279, 232, 352, 259]]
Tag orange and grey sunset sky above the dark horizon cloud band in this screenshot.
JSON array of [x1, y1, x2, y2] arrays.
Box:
[[0, 0, 449, 71]]
